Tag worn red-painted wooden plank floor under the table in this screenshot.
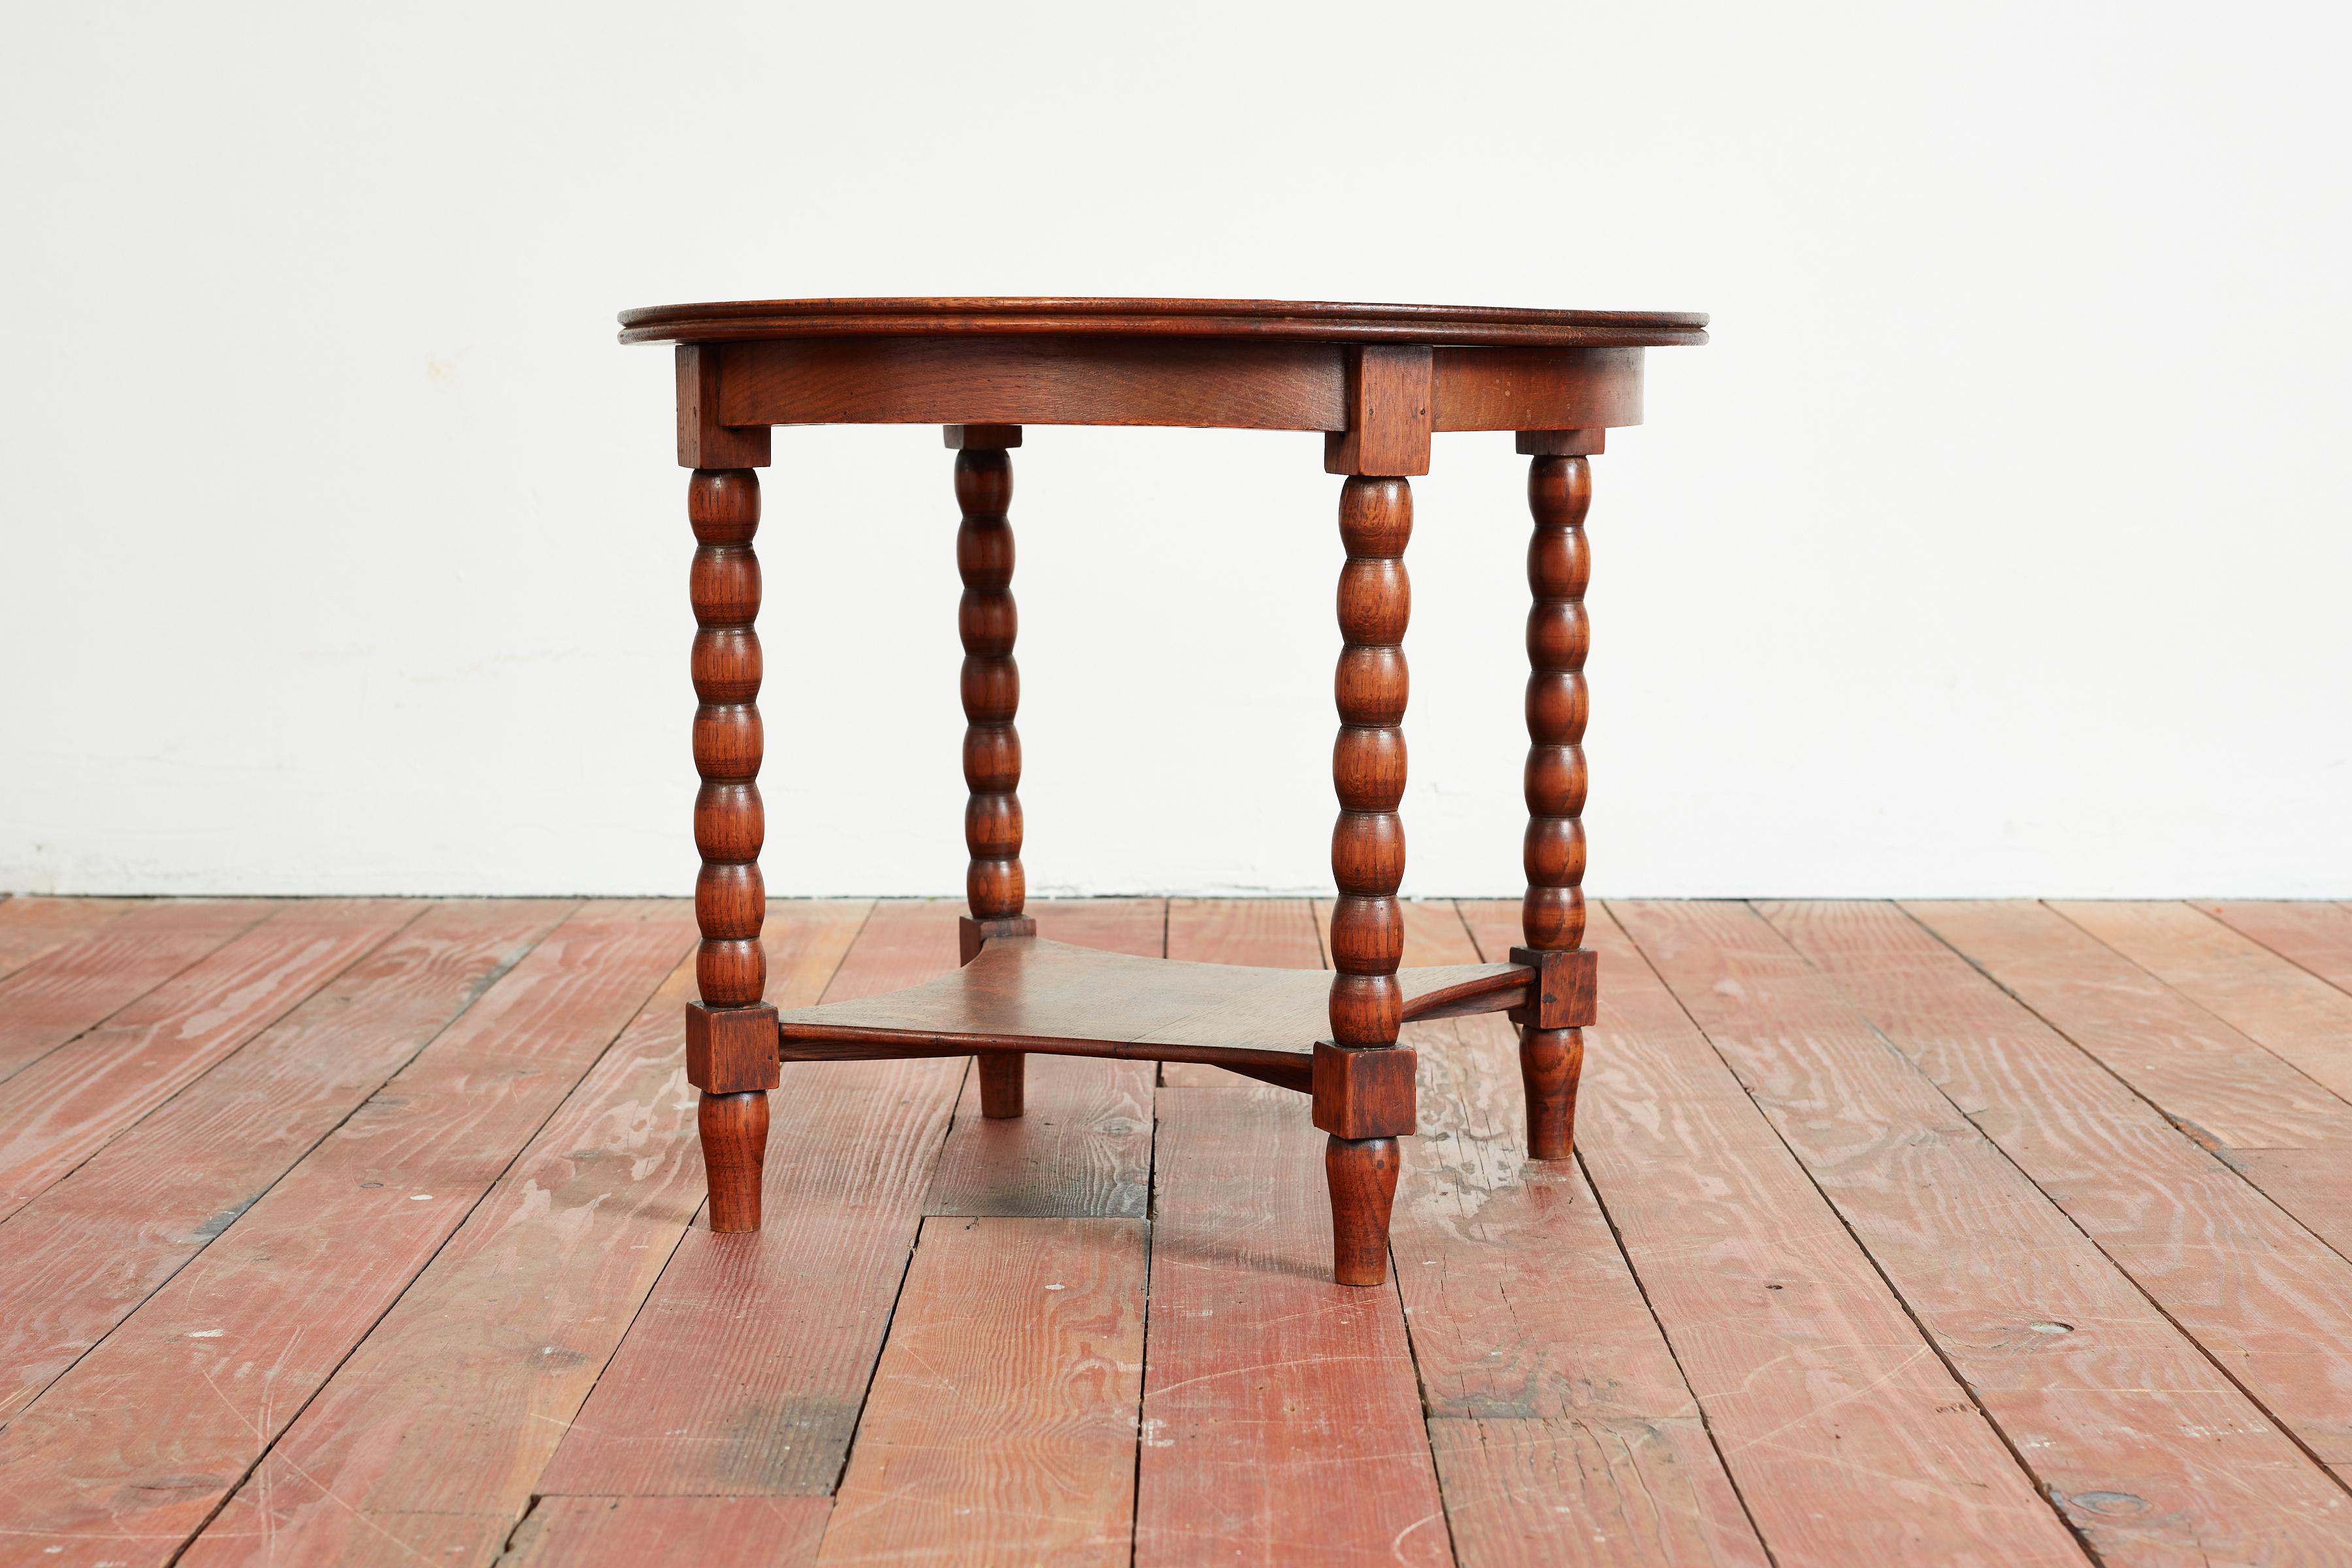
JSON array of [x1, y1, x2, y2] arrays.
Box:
[[0, 898, 2352, 1568]]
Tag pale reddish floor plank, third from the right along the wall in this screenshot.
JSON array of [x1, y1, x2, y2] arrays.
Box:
[[1903, 903, 2352, 1255]]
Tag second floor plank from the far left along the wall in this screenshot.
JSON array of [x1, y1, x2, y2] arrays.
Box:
[[0, 898, 282, 1079]]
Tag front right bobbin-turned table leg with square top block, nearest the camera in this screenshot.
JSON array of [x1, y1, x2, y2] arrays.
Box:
[[1313, 348, 1430, 1286]]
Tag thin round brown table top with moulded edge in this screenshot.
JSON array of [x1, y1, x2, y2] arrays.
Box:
[[621, 299, 1708, 348]]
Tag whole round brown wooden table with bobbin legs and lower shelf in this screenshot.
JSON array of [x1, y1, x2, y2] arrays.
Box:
[[621, 299, 1708, 1286]]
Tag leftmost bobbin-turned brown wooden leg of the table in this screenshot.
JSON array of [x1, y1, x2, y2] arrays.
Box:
[[679, 472, 776, 1230]]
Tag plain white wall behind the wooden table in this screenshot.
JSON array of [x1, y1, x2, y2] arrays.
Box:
[[0, 0, 2352, 896]]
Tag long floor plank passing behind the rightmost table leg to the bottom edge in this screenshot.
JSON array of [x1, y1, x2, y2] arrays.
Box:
[[1465, 903, 2086, 1563]]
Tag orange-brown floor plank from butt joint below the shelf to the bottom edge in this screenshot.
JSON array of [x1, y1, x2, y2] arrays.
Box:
[[819, 1218, 1145, 1568]]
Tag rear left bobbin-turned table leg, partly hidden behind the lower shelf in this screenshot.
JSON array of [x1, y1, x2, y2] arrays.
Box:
[[948, 425, 1037, 1119]]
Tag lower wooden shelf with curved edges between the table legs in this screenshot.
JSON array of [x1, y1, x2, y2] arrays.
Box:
[[779, 938, 1531, 1088]]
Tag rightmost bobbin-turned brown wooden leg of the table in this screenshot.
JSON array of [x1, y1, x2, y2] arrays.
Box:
[[1510, 430, 1602, 1159]]
